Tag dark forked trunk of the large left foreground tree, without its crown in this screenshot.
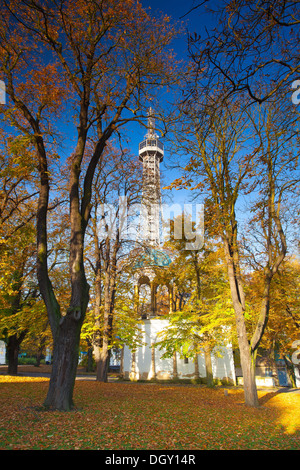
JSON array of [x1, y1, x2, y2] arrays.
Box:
[[42, 120, 90, 411]]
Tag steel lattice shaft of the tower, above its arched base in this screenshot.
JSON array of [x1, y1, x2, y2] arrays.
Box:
[[139, 108, 164, 246]]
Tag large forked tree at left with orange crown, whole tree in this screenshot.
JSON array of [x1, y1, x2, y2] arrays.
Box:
[[0, 0, 178, 410]]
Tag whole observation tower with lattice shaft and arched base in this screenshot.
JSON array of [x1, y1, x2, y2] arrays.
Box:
[[134, 108, 172, 319]]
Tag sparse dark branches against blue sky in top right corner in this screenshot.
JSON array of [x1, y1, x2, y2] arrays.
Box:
[[189, 0, 300, 103]]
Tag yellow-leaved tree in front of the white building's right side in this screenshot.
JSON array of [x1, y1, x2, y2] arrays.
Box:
[[157, 216, 233, 386]]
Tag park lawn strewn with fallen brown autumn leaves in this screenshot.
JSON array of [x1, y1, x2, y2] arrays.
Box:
[[0, 375, 300, 450]]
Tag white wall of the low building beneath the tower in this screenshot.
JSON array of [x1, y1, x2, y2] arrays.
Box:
[[123, 318, 235, 383]]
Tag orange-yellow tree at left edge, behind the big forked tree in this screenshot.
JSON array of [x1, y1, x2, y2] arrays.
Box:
[[0, 129, 37, 374]]
